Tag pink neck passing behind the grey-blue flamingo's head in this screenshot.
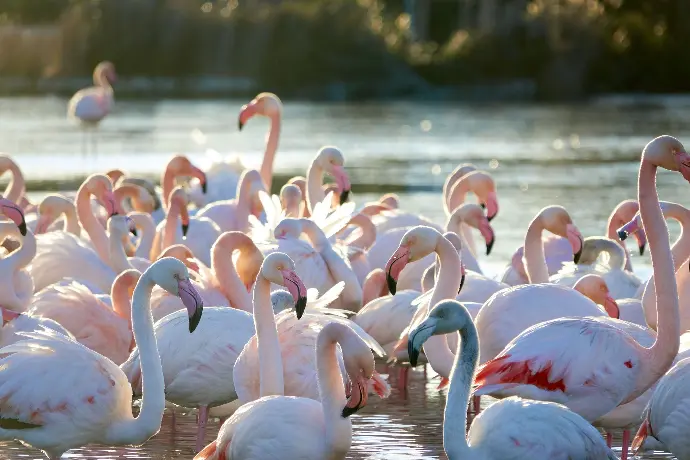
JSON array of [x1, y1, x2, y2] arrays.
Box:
[[424, 237, 461, 378]]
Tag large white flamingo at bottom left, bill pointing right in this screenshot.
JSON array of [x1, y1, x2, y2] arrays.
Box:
[[0, 258, 203, 459]]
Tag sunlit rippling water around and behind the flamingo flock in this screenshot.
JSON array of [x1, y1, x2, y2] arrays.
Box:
[[0, 97, 690, 459]]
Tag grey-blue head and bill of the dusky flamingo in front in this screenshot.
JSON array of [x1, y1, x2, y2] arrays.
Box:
[[407, 300, 478, 367]]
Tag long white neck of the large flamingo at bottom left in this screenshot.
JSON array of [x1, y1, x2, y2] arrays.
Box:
[[104, 268, 165, 445]]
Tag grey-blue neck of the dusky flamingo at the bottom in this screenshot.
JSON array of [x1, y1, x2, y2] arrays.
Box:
[[443, 325, 479, 460]]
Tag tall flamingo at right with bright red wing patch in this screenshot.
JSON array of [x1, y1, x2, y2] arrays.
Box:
[[475, 136, 690, 458]]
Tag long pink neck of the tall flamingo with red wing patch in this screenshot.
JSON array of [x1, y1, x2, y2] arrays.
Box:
[[628, 158, 680, 400]]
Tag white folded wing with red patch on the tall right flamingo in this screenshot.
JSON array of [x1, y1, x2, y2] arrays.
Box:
[[474, 318, 640, 420]]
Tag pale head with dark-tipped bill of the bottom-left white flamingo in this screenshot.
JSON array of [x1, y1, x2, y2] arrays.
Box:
[[150, 257, 204, 333]]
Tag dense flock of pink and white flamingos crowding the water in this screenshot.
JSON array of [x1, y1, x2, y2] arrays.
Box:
[[0, 62, 690, 460]]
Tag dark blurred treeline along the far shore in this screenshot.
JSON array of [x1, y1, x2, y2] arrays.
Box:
[[0, 0, 690, 99]]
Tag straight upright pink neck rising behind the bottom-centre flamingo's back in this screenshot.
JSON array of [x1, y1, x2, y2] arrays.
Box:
[[254, 273, 285, 398]]
